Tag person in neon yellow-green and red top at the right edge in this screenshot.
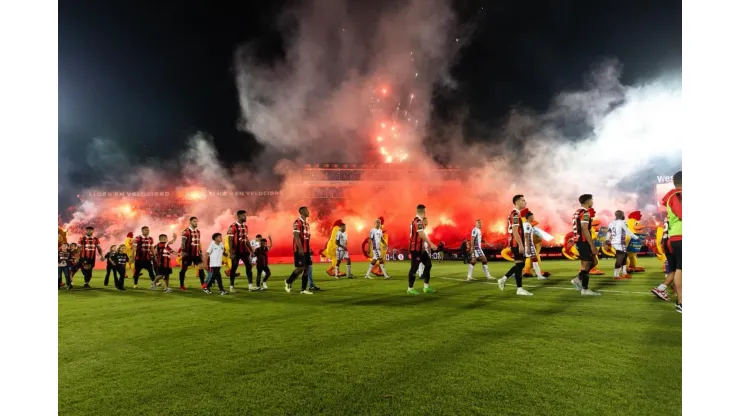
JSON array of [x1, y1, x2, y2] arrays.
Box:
[[661, 171, 683, 313]]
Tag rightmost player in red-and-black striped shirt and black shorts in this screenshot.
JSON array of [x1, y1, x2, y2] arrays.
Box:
[[570, 194, 601, 296]]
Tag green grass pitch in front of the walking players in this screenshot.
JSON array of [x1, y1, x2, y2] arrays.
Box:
[[59, 259, 681, 415]]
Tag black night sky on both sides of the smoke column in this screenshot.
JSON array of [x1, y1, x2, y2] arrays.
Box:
[[59, 0, 681, 203]]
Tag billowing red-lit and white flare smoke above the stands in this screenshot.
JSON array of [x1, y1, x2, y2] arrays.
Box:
[[62, 0, 683, 264]]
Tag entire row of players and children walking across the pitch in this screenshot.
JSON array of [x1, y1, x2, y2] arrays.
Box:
[[58, 172, 682, 312]]
